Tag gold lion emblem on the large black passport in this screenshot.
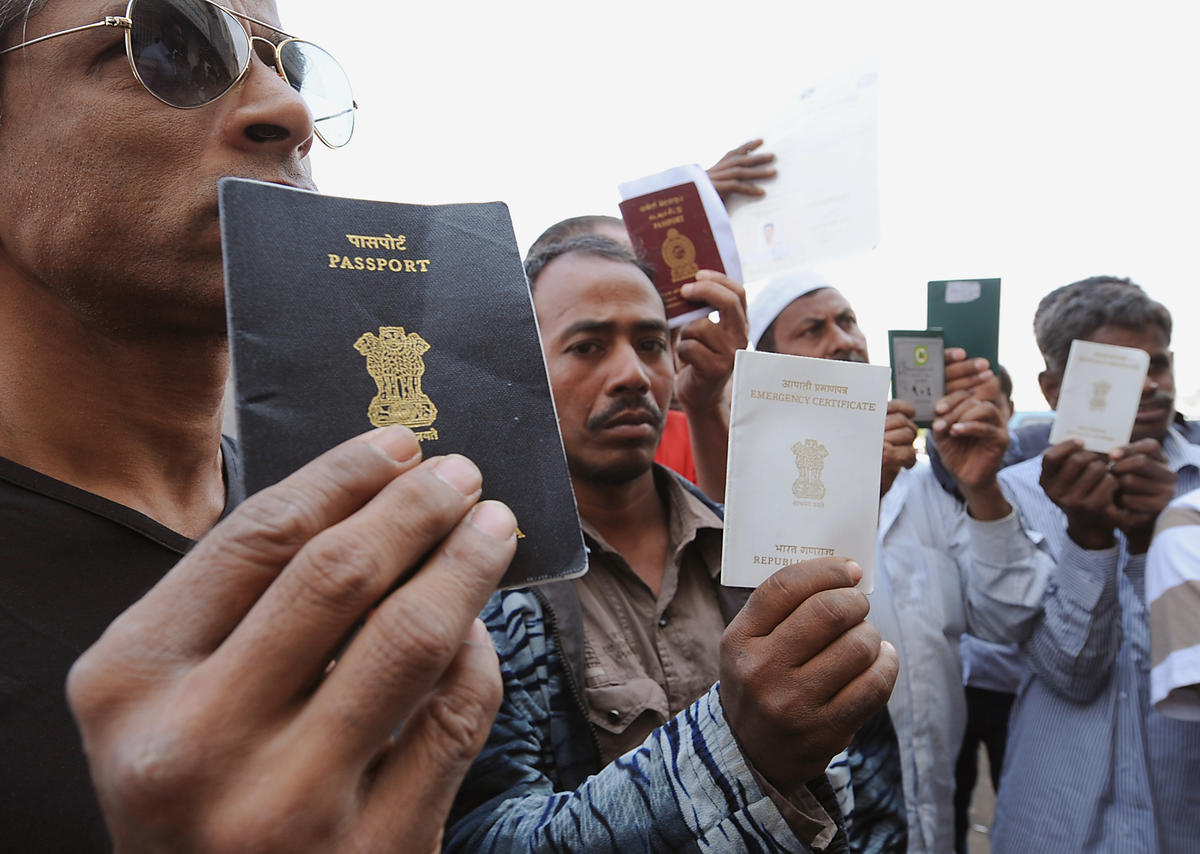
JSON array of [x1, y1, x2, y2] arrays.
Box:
[[354, 326, 438, 440]]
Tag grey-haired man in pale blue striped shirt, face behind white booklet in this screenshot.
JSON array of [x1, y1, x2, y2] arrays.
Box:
[[974, 276, 1200, 854]]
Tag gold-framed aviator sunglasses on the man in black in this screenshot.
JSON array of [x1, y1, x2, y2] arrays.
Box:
[[0, 0, 358, 149]]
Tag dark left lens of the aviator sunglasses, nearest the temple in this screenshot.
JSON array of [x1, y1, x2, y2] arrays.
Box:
[[130, 0, 250, 108]]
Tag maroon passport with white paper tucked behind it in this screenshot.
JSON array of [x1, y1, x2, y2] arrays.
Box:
[[620, 166, 742, 326]]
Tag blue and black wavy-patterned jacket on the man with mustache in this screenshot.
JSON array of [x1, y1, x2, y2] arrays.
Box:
[[444, 470, 845, 854]]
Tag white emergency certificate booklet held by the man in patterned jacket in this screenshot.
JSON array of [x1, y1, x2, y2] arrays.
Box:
[[721, 350, 892, 593]]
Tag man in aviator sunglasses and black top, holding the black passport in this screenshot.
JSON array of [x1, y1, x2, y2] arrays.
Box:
[[0, 0, 515, 853]]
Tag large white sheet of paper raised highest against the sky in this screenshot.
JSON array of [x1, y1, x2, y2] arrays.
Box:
[[728, 68, 880, 282]]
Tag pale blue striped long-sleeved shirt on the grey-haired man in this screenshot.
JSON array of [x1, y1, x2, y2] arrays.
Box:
[[973, 428, 1200, 854]]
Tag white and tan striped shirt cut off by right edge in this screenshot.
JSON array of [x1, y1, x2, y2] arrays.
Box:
[[1146, 489, 1200, 721]]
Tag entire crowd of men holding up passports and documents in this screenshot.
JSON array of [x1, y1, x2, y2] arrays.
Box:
[[0, 0, 1200, 854]]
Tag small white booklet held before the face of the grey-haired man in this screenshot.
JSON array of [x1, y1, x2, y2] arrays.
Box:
[[1050, 338, 1150, 453]]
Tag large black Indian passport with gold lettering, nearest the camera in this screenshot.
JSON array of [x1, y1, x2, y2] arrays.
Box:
[[220, 179, 587, 587]]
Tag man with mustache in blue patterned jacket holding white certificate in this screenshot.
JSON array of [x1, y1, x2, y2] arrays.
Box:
[[446, 234, 895, 852]]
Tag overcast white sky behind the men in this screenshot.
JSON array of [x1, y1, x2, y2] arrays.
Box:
[[278, 0, 1200, 415]]
